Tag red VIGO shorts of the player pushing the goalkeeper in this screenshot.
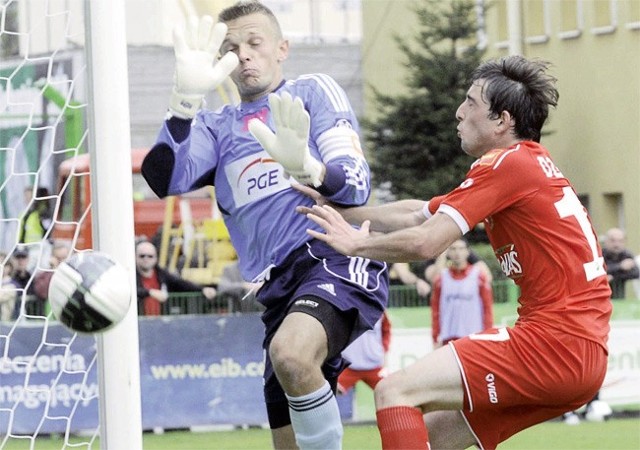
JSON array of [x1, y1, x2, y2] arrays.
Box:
[[449, 323, 607, 449]]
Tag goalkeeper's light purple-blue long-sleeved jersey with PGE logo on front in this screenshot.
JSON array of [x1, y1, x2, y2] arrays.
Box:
[[158, 74, 370, 280]]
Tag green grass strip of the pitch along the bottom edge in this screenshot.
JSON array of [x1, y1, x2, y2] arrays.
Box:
[[3, 419, 640, 450]]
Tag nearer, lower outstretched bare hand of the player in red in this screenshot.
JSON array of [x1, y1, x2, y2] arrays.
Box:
[[307, 205, 370, 256]]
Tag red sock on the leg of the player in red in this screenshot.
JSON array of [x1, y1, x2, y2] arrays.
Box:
[[376, 406, 431, 450]]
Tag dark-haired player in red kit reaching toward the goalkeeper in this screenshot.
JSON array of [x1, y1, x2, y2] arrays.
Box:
[[298, 56, 611, 449]]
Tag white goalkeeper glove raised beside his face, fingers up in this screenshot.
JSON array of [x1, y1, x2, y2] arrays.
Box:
[[169, 16, 239, 119]]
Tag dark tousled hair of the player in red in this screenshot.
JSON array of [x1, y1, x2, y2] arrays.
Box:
[[471, 55, 559, 142]]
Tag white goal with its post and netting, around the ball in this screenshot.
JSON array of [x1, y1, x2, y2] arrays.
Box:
[[0, 0, 142, 449]]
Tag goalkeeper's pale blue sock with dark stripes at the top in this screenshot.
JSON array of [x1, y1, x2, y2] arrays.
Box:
[[287, 381, 343, 450]]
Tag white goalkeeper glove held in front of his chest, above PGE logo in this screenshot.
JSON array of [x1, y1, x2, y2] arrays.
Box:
[[249, 92, 324, 187]]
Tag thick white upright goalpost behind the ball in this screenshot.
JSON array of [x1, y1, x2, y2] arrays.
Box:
[[85, 0, 142, 450]]
